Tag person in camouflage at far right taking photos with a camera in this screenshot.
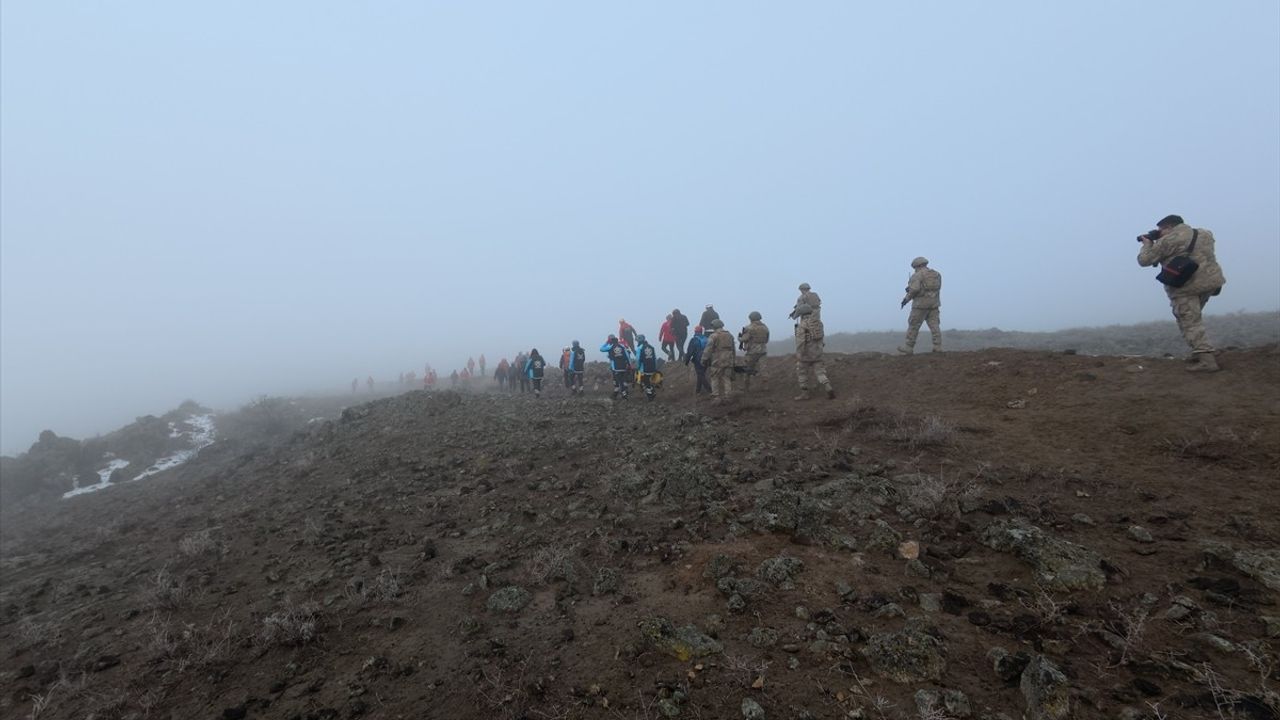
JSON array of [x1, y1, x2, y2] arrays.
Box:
[[1138, 215, 1226, 373]]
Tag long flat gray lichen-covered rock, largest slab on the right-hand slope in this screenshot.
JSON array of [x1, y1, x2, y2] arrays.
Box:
[[982, 519, 1107, 591]]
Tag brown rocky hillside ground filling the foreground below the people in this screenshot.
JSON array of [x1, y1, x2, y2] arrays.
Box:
[[0, 347, 1280, 720]]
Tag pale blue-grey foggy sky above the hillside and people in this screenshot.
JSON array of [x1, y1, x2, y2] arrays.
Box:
[[0, 0, 1280, 454]]
